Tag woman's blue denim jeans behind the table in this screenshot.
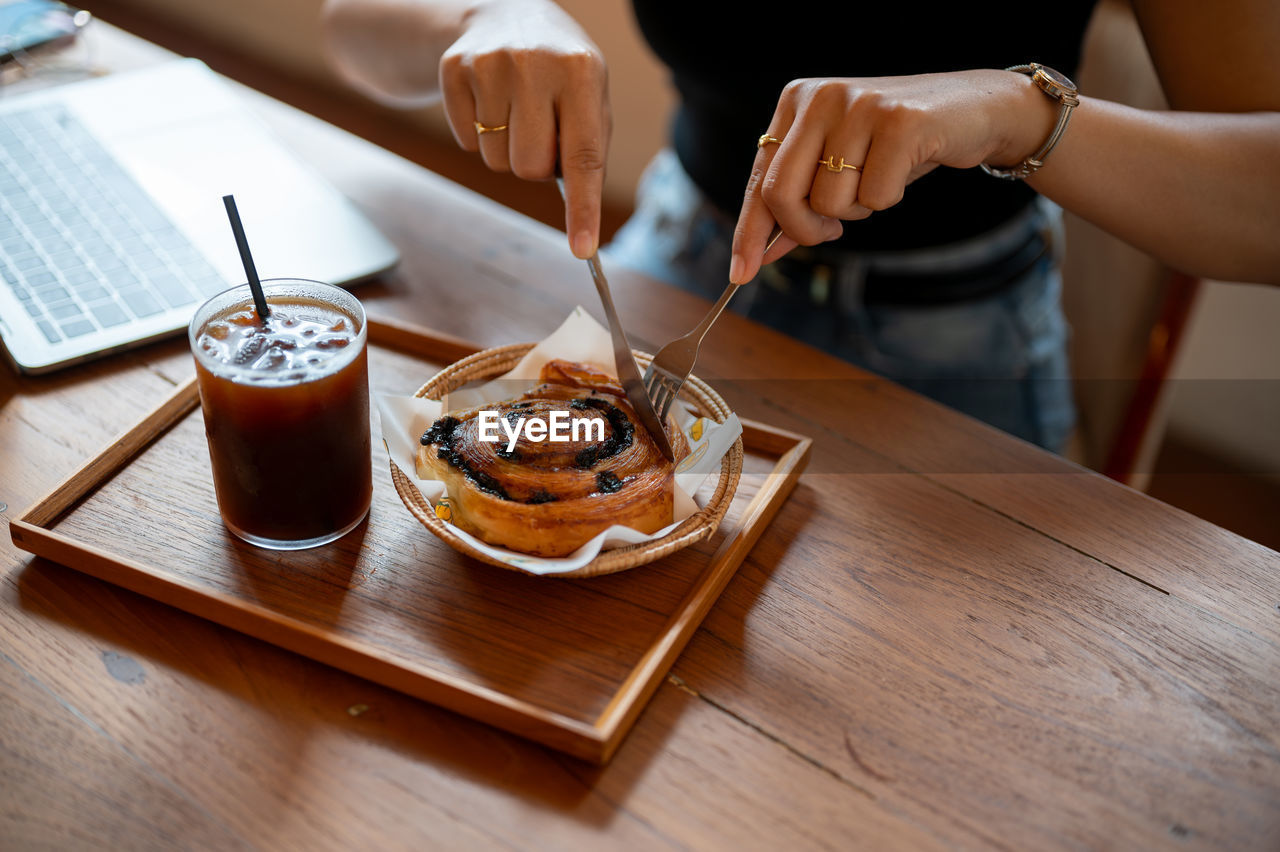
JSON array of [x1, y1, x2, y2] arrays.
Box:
[[605, 151, 1075, 452]]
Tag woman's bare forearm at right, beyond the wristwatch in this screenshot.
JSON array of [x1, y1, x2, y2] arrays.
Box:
[[1029, 99, 1280, 284]]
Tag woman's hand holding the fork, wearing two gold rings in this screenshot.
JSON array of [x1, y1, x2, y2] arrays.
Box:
[[730, 70, 1057, 284]]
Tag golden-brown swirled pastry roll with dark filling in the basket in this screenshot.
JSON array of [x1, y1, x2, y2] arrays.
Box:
[[417, 361, 689, 556]]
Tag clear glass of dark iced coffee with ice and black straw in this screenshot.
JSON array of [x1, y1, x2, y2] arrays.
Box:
[[188, 279, 372, 550]]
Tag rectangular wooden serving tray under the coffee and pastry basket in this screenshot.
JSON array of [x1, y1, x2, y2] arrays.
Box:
[[10, 320, 810, 764]]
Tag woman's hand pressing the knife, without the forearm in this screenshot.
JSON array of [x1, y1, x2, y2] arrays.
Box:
[[439, 0, 612, 257]]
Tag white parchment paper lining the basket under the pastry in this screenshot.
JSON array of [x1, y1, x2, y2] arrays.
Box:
[[376, 307, 742, 574]]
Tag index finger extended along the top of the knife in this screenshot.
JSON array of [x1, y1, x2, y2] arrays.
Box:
[[557, 86, 609, 258]]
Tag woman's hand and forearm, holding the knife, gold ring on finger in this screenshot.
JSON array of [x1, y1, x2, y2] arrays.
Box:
[[323, 0, 612, 257]]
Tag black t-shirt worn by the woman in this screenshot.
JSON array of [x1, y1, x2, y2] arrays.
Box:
[[634, 0, 1094, 249]]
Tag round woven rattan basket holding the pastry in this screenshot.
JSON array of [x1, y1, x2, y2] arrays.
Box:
[[390, 343, 742, 577]]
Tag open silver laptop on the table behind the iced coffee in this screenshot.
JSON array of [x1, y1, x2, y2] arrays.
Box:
[[0, 59, 399, 374]]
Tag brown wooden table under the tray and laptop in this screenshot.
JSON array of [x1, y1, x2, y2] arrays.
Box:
[[0, 23, 1280, 849]]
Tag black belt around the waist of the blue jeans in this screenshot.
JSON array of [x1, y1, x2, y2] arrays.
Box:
[[777, 232, 1050, 307]]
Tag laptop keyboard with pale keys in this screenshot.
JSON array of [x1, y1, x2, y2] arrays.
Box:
[[0, 104, 228, 343]]
